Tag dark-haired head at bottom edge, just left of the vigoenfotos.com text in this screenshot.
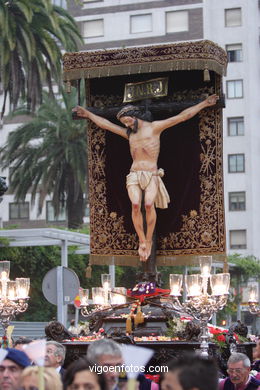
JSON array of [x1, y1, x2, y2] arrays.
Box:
[[64, 358, 107, 390]]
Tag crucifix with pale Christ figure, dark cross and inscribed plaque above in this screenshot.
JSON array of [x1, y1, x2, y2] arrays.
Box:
[[73, 79, 219, 263]]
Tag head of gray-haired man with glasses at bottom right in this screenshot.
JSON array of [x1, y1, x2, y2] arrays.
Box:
[[227, 352, 251, 385]]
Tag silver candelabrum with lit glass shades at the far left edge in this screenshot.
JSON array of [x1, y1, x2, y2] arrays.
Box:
[[0, 260, 30, 337]]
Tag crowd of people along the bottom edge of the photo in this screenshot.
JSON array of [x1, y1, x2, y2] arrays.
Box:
[[0, 339, 260, 390]]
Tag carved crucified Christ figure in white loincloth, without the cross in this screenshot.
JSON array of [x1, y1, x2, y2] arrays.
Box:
[[73, 95, 219, 261]]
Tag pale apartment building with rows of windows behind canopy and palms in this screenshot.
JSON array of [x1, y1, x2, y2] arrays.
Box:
[[0, 0, 260, 258]]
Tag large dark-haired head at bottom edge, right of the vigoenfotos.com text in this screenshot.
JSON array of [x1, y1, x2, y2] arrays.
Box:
[[161, 355, 218, 390]]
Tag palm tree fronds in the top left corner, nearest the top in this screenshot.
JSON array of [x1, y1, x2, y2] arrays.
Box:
[[0, 0, 82, 119]]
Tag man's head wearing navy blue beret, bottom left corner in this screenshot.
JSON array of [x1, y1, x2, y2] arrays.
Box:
[[0, 348, 31, 390]]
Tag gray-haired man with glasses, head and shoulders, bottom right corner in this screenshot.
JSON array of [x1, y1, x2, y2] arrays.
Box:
[[219, 352, 260, 390]]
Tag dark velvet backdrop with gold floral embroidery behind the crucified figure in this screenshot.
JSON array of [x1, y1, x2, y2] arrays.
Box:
[[88, 71, 225, 264]]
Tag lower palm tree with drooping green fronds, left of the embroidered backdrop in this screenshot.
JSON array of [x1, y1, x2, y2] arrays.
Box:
[[0, 90, 87, 228]]
